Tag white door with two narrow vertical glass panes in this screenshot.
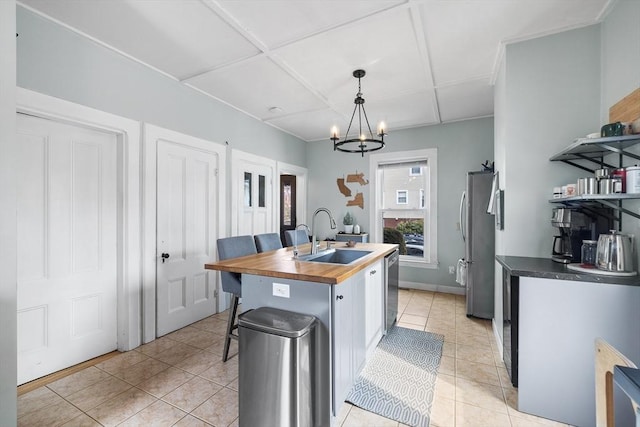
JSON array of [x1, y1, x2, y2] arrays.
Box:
[[232, 154, 278, 236]]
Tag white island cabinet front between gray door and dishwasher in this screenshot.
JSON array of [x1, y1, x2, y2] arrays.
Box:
[[364, 261, 385, 359]]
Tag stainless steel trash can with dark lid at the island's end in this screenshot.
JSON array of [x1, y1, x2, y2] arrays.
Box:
[[238, 307, 317, 427]]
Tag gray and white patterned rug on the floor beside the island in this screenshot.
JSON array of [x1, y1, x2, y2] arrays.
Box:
[[346, 326, 444, 427]]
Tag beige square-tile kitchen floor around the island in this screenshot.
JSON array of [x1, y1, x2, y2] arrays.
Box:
[[18, 290, 562, 427]]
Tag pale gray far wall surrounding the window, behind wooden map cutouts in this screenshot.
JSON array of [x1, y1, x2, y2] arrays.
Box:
[[307, 118, 493, 289]]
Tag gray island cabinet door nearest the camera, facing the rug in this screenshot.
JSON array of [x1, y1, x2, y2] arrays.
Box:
[[331, 278, 354, 416]]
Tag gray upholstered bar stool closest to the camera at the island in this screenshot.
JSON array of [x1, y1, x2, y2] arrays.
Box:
[[218, 236, 258, 362]]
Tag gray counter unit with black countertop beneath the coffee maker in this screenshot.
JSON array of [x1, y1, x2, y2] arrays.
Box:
[[496, 256, 640, 426]]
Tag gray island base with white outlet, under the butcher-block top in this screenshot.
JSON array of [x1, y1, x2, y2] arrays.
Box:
[[242, 270, 383, 426]]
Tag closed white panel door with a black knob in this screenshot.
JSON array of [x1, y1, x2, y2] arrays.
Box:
[[156, 139, 219, 336]]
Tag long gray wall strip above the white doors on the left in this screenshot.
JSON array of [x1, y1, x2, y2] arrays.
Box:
[[17, 7, 306, 166]]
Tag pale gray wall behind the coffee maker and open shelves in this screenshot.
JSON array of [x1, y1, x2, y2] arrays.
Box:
[[494, 25, 600, 340]]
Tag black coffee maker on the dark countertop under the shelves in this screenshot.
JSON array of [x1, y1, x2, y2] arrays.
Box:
[[551, 208, 608, 264]]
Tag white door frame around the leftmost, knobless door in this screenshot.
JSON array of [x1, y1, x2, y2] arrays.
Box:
[[16, 87, 142, 351]]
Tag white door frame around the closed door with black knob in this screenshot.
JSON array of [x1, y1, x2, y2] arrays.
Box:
[[142, 123, 227, 343]]
